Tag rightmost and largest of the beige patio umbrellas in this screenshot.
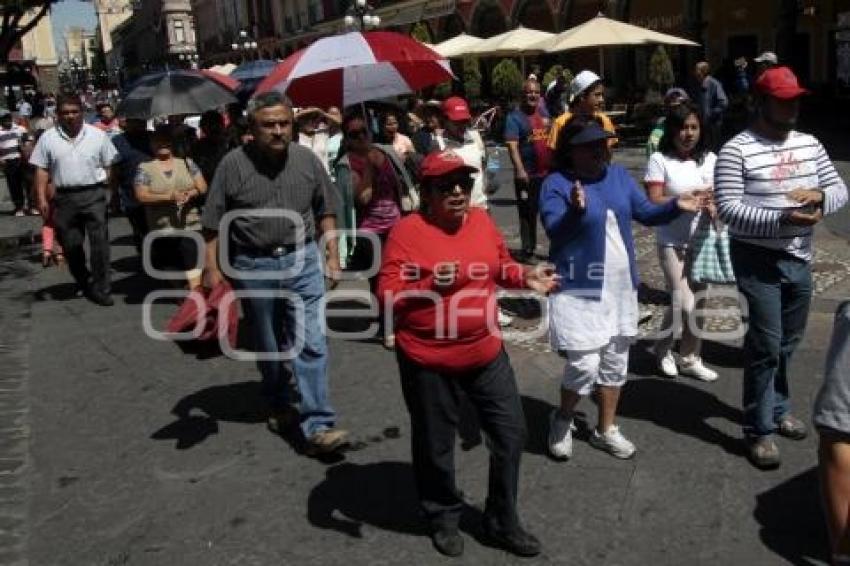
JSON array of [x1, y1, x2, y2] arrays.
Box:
[[534, 13, 699, 73]]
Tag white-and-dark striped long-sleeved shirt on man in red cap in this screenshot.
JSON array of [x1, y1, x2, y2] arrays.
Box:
[[714, 130, 847, 261]]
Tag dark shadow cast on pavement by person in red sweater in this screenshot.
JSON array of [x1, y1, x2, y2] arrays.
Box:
[[307, 462, 483, 542]]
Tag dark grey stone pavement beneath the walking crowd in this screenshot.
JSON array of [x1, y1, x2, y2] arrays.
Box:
[[0, 149, 850, 566]]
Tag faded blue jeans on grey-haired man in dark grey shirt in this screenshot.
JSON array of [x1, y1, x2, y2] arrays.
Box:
[[233, 242, 336, 438]]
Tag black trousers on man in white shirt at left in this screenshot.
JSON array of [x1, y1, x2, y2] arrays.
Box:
[[54, 188, 110, 293]]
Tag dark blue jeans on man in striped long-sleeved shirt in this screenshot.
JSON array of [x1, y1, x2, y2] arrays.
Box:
[[731, 240, 812, 437]]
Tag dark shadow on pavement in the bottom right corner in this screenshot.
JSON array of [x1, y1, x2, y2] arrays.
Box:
[[753, 467, 829, 566]]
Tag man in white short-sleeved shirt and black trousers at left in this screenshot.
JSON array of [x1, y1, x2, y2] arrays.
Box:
[[30, 95, 118, 306]]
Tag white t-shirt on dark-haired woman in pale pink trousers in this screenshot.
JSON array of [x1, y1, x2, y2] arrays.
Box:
[[643, 151, 717, 248]]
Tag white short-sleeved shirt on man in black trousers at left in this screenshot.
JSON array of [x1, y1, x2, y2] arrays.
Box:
[[30, 124, 119, 189]]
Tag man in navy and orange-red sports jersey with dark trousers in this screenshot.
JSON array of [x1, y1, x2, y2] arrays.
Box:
[[505, 80, 552, 262]]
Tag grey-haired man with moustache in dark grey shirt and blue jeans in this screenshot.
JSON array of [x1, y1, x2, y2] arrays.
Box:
[[201, 92, 347, 455]]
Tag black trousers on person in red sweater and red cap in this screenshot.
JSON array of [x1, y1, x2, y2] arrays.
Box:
[[396, 349, 525, 530]]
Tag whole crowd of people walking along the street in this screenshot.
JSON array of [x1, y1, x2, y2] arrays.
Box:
[[0, 54, 850, 560]]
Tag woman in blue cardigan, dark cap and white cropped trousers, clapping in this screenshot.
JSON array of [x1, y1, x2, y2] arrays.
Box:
[[540, 116, 701, 459]]
